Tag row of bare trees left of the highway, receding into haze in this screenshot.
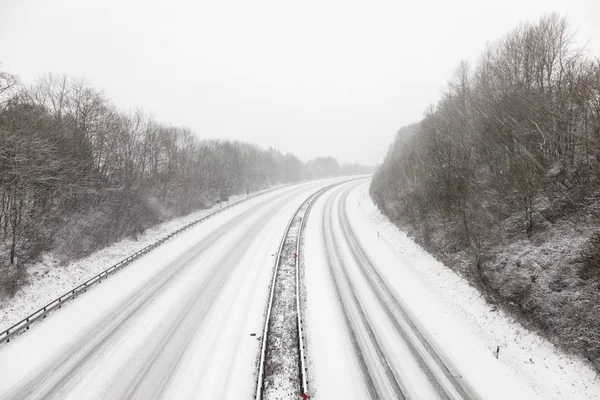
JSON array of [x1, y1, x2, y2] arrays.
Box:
[[0, 68, 356, 296]]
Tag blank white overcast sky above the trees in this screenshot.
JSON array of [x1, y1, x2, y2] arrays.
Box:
[[0, 0, 600, 164]]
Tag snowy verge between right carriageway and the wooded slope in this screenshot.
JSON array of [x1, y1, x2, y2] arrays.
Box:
[[356, 184, 600, 399]]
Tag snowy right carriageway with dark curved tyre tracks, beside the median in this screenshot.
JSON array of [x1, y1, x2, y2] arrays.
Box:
[[304, 181, 540, 399]]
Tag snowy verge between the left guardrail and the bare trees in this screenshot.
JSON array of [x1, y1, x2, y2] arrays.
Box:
[[0, 183, 286, 332]]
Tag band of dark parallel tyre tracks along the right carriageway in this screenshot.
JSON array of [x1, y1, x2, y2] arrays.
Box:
[[316, 184, 474, 399]]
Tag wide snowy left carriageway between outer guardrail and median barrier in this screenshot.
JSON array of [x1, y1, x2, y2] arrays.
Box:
[[0, 181, 342, 399]]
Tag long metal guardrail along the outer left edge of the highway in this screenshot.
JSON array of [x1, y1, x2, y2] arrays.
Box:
[[0, 182, 290, 344]]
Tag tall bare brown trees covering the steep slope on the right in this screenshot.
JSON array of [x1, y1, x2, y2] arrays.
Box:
[[371, 14, 600, 367]]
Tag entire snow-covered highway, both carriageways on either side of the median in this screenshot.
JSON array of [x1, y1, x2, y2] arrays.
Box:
[[0, 178, 596, 400]]
